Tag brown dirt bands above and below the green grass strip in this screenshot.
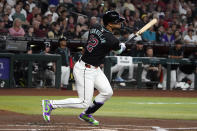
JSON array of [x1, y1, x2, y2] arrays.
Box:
[[0, 89, 197, 131]]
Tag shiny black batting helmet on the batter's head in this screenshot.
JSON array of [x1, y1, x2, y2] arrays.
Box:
[[103, 11, 124, 25]]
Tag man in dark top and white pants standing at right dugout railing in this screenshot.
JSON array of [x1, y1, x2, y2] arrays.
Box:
[[162, 40, 183, 90]]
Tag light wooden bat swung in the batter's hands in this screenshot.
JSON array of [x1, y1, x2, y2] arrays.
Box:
[[125, 18, 157, 44]]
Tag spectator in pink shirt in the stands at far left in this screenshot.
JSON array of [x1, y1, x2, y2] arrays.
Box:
[[9, 18, 25, 37]]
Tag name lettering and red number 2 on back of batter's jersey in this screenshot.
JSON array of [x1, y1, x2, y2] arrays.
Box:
[[87, 28, 106, 52]]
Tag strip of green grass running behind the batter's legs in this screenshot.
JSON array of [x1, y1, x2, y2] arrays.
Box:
[[0, 96, 197, 120]]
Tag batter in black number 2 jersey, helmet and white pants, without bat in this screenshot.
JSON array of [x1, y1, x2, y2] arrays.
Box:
[[42, 11, 126, 125]]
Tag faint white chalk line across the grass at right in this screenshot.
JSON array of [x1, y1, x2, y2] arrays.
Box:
[[128, 102, 197, 105]]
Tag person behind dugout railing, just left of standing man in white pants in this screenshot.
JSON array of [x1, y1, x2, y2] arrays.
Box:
[[40, 42, 55, 87]]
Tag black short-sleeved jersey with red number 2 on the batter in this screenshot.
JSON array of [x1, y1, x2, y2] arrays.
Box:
[[81, 25, 120, 66]]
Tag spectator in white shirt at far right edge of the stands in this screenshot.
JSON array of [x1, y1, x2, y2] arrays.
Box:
[[184, 29, 197, 45]]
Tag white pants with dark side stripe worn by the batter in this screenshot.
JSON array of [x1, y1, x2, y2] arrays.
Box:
[[50, 60, 113, 108]]
